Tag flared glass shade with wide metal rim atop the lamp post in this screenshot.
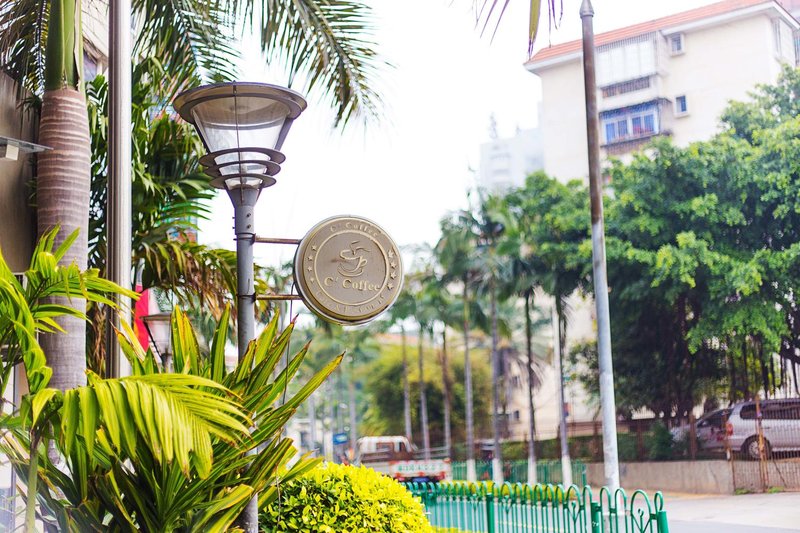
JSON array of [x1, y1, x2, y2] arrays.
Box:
[[175, 82, 306, 154]]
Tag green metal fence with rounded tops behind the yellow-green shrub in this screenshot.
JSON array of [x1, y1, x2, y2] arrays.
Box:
[[406, 482, 669, 533]]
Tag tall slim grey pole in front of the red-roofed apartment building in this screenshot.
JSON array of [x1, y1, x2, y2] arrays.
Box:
[[580, 0, 619, 494]]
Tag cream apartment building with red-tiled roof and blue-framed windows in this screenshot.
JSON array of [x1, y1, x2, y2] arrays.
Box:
[[526, 0, 800, 179]]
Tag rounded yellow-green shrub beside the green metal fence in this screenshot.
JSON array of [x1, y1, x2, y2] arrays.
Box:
[[259, 463, 433, 533]]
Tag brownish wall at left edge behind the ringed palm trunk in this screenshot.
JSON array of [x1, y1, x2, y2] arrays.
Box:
[[0, 74, 36, 272]]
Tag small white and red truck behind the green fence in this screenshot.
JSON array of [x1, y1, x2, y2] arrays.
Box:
[[355, 436, 452, 482]]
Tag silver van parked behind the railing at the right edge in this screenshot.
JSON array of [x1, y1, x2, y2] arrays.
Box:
[[715, 398, 800, 459]]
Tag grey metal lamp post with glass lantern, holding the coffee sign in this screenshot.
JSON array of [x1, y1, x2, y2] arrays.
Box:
[[174, 82, 306, 533]]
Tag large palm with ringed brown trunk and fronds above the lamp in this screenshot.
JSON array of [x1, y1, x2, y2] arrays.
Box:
[[0, 0, 386, 389]]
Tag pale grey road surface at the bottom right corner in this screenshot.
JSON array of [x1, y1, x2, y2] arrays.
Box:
[[664, 492, 800, 533]]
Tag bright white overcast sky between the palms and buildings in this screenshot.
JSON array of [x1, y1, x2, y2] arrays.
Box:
[[199, 0, 711, 265]]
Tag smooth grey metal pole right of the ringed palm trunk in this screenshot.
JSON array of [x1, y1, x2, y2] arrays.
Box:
[[106, 0, 132, 377]]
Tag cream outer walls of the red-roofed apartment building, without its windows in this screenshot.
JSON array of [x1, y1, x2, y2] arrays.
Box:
[[536, 12, 792, 181]]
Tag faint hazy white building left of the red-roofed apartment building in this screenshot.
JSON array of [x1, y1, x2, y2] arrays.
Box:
[[478, 128, 544, 192]]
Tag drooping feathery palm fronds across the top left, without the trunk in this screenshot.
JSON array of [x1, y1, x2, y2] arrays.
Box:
[[0, 0, 380, 125]]
